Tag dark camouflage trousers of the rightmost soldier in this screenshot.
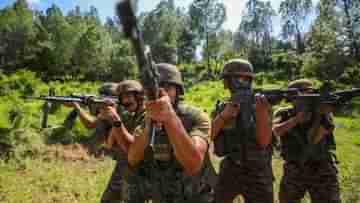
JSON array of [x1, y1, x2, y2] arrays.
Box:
[[279, 161, 341, 203]]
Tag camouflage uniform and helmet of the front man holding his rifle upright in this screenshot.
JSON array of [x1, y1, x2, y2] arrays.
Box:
[[129, 64, 215, 203]]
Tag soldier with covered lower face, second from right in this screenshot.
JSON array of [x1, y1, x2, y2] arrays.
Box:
[[211, 59, 273, 203]]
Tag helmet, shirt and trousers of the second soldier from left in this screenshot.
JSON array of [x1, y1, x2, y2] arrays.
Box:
[[101, 80, 145, 203]]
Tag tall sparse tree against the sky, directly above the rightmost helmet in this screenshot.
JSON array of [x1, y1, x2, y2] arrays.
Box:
[[279, 0, 312, 54]]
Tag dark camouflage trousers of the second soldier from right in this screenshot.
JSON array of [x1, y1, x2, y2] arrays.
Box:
[[215, 158, 274, 203]]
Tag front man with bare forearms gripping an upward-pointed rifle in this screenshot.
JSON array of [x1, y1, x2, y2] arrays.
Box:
[[128, 63, 213, 203]]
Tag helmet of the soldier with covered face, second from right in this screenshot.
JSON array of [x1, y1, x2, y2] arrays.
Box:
[[220, 59, 254, 79]]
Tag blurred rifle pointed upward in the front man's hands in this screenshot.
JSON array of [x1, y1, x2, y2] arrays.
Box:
[[116, 0, 159, 148]]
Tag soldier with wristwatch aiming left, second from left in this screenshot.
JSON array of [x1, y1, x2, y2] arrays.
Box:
[[101, 80, 144, 203]]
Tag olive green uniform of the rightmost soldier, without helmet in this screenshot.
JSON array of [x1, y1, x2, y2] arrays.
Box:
[[274, 107, 341, 203]]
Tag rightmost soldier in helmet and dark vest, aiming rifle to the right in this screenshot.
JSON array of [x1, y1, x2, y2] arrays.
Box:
[[273, 79, 341, 203]]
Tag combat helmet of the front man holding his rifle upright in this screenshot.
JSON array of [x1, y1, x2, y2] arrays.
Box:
[[156, 63, 184, 95]]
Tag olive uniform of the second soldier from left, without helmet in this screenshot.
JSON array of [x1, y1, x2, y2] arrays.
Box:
[[101, 112, 145, 203]]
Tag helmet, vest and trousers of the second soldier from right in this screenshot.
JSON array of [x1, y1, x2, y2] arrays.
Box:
[[213, 60, 273, 203]]
